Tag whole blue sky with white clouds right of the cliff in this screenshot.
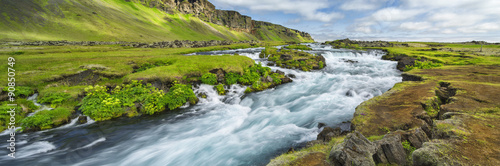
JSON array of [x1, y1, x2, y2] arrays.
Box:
[[210, 0, 500, 42]]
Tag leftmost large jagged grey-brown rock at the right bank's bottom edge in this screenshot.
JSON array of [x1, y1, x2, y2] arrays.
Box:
[[328, 131, 376, 166]]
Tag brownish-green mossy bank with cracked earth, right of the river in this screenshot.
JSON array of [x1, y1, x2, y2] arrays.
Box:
[[269, 42, 500, 165]]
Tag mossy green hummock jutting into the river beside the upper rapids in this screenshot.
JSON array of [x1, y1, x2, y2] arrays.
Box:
[[259, 46, 325, 71]]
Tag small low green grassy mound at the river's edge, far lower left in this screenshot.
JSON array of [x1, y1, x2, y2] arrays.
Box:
[[21, 107, 73, 130]]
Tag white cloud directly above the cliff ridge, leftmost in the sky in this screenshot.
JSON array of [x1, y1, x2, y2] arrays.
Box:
[[214, 0, 344, 22]]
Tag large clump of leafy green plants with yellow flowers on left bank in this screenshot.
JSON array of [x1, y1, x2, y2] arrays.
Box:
[[80, 80, 197, 121]]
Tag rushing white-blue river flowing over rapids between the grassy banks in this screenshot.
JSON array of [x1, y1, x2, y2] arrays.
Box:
[[0, 45, 401, 166]]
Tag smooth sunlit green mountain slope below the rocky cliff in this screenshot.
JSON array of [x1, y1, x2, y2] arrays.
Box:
[[0, 0, 310, 42]]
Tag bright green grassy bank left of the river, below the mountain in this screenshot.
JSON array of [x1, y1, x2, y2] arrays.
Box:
[[0, 42, 284, 130]]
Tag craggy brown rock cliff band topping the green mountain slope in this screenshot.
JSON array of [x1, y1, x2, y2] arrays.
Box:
[[133, 0, 313, 41]]
